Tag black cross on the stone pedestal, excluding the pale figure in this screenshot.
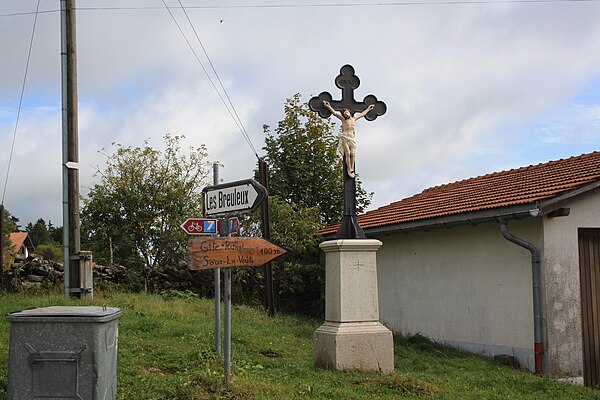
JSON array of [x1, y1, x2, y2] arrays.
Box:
[[308, 64, 387, 239]]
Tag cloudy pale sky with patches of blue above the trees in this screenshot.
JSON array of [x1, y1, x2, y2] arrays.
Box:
[[0, 0, 600, 226]]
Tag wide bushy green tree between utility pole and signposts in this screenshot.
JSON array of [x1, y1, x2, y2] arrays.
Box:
[[81, 135, 208, 268]]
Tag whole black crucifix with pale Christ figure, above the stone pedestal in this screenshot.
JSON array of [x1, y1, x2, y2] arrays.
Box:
[[308, 65, 387, 239]]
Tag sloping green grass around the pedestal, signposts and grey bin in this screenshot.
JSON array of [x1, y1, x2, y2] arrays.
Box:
[[0, 293, 600, 400]]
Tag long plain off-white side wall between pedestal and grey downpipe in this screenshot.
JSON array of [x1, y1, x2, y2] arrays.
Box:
[[377, 218, 542, 369]]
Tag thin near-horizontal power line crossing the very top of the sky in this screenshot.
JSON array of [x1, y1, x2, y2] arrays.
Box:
[[0, 0, 600, 17]]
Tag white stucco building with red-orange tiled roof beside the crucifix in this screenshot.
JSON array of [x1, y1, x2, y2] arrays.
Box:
[[322, 152, 600, 386]]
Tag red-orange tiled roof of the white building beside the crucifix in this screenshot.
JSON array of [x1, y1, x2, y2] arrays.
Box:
[[320, 151, 600, 235]]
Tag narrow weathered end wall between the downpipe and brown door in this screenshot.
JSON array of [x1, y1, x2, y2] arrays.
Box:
[[542, 190, 600, 377]]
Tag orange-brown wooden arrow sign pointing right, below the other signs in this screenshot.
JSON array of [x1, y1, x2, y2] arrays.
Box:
[[188, 236, 287, 270]]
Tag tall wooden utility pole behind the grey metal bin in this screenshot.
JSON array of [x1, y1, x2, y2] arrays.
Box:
[[60, 0, 82, 297]]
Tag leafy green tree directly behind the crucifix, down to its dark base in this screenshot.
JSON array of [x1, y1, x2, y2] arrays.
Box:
[[236, 94, 371, 314]]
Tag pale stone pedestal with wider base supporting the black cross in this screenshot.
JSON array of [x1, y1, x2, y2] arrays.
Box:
[[314, 239, 394, 373]]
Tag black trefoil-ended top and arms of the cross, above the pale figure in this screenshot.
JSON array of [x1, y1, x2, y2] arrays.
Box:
[[308, 64, 387, 121]]
